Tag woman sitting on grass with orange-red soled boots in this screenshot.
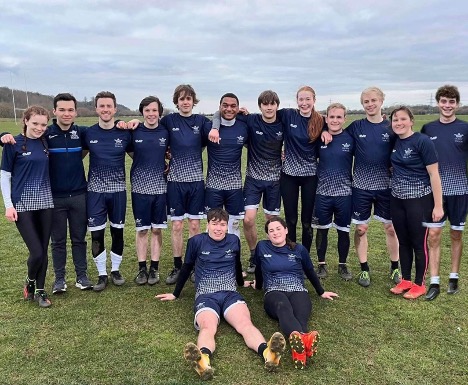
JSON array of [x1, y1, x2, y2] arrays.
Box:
[[253, 217, 338, 369]]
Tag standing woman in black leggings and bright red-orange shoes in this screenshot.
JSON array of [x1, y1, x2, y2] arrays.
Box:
[[390, 107, 444, 299]]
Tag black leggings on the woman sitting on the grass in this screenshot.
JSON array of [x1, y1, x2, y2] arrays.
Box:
[[263, 290, 312, 336]]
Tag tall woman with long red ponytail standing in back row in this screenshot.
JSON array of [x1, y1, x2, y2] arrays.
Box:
[[278, 86, 325, 251]]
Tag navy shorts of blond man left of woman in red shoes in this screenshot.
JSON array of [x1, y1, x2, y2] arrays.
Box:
[[352, 187, 392, 225]]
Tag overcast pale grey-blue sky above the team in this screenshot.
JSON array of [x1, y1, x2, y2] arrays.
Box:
[[0, 0, 468, 113]]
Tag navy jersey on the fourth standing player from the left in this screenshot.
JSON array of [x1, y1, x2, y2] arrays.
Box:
[[130, 123, 169, 195]]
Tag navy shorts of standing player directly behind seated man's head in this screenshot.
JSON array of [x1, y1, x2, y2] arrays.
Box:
[[205, 187, 245, 219]]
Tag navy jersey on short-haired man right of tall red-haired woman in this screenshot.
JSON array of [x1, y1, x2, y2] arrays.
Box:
[[317, 130, 354, 196]]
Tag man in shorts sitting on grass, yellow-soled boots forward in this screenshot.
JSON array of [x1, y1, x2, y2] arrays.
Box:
[[156, 208, 286, 380]]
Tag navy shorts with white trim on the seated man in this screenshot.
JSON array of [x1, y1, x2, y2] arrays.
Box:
[[193, 291, 245, 330]]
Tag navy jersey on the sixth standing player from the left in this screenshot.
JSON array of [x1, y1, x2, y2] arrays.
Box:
[[204, 120, 249, 190]]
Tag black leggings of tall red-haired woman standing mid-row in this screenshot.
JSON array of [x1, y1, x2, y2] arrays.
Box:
[[280, 172, 317, 252]]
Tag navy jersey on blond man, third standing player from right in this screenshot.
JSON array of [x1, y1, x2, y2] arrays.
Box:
[[346, 119, 395, 190]]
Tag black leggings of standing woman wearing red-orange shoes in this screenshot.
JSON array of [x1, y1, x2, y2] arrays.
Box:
[[390, 194, 434, 285]]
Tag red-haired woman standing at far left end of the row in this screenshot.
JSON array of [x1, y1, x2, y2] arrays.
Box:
[[1, 106, 54, 307]]
